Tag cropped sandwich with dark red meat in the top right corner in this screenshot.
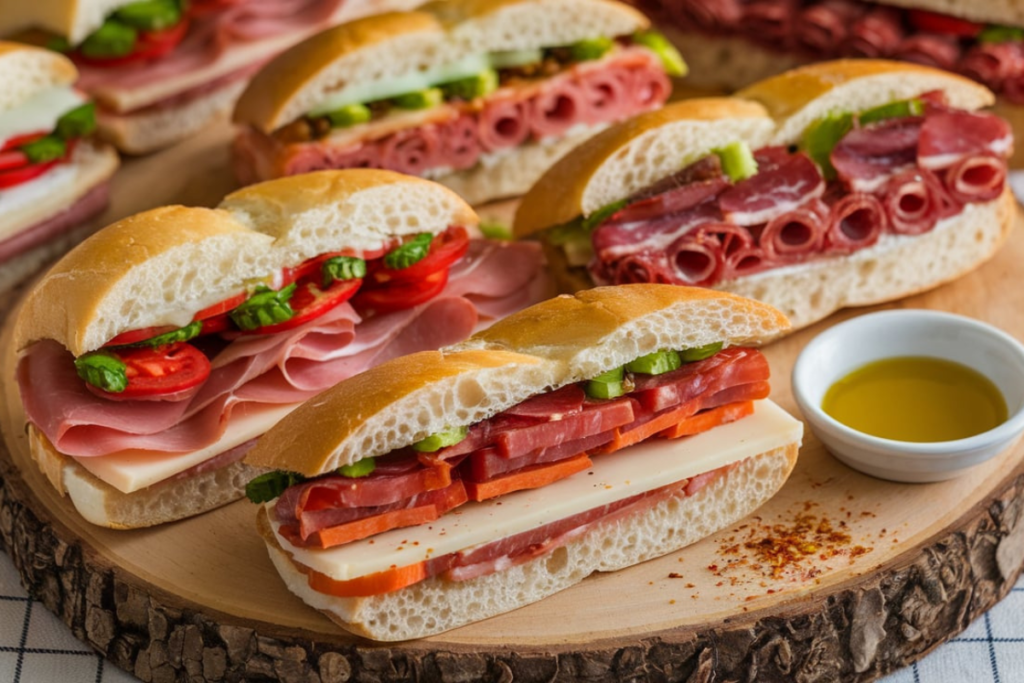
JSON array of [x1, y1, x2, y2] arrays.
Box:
[[632, 0, 1024, 166]]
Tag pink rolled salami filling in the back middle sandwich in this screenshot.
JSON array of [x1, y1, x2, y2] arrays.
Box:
[[234, 47, 672, 182]]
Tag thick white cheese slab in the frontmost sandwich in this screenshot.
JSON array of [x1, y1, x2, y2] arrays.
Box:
[[276, 399, 804, 581]]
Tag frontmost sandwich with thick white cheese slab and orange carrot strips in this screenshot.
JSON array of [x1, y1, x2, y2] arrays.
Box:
[[247, 285, 802, 641]]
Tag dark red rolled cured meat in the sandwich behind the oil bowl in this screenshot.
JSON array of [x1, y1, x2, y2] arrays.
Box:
[[589, 93, 1013, 287]]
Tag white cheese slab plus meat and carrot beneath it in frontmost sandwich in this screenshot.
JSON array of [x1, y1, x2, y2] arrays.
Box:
[[268, 400, 802, 597]]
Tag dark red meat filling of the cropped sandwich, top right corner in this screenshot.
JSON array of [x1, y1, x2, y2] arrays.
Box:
[[632, 0, 1024, 103]]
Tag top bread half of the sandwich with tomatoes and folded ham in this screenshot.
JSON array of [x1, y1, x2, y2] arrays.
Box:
[[15, 170, 477, 355]]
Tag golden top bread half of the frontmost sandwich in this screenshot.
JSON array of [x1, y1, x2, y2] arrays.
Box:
[[246, 285, 790, 475]]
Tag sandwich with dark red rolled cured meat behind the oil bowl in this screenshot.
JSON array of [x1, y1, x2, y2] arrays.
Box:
[[514, 60, 1017, 328]]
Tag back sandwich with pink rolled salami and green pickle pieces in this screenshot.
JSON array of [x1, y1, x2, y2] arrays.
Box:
[[232, 0, 685, 204]]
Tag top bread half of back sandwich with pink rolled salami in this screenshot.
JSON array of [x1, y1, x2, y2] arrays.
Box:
[[234, 0, 648, 132]]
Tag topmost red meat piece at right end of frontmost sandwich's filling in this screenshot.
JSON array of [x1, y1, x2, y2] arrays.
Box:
[[630, 346, 770, 413]]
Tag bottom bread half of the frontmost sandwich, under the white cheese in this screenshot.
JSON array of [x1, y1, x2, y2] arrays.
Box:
[[257, 443, 799, 641]]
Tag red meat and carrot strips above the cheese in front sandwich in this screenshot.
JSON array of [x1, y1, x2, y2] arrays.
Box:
[[272, 347, 769, 548]]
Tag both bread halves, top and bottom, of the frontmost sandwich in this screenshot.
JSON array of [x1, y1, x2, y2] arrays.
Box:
[[246, 285, 800, 640]]
